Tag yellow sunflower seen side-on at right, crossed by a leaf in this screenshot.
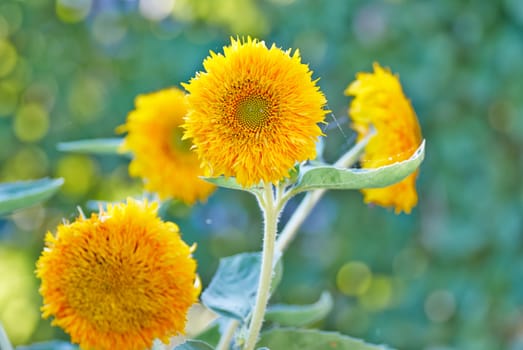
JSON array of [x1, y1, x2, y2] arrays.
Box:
[[345, 63, 422, 214]]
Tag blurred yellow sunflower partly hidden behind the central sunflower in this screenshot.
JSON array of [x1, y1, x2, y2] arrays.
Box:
[[118, 88, 215, 204]]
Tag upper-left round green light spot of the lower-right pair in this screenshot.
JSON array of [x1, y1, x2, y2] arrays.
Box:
[[336, 261, 372, 296]]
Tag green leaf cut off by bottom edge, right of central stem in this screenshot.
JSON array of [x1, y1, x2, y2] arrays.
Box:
[[257, 328, 391, 350]]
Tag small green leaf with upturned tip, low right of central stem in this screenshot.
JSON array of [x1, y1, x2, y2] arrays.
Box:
[[265, 292, 332, 327]]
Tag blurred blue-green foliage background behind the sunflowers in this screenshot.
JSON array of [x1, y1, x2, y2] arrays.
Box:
[[0, 0, 523, 350]]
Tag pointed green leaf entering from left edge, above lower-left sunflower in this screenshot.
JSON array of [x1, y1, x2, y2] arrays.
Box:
[[0, 178, 64, 215]]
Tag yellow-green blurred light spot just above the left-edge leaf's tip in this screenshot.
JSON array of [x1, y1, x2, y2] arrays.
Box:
[[56, 154, 97, 197]]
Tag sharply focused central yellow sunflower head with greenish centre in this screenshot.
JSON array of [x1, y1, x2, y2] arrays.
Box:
[[184, 38, 327, 187]]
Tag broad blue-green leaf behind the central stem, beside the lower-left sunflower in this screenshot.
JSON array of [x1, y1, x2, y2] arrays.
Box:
[[202, 253, 282, 322]]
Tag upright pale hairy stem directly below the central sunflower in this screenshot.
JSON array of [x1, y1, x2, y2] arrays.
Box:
[[247, 183, 281, 350]]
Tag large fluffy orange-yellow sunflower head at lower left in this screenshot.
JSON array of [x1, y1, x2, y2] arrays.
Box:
[[36, 199, 200, 350]]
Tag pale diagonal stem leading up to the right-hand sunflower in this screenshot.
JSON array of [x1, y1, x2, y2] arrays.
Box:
[[276, 128, 376, 252]]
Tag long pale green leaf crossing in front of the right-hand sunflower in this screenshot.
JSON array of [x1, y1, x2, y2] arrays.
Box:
[[293, 141, 425, 194]]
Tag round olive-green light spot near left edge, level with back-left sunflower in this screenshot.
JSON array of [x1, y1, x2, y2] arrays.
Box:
[[13, 103, 49, 142]]
